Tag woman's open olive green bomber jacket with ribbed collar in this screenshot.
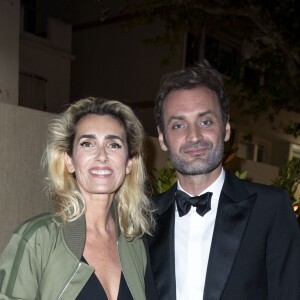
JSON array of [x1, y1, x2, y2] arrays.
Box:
[[0, 214, 147, 300]]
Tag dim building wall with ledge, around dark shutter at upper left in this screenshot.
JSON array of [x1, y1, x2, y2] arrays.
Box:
[[19, 19, 73, 112]]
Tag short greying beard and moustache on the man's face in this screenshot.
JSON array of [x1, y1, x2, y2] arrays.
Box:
[[167, 141, 224, 176]]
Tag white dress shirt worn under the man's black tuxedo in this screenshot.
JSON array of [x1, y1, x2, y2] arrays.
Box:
[[175, 169, 225, 300]]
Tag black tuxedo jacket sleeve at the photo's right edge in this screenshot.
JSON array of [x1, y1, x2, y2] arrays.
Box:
[[266, 192, 300, 300]]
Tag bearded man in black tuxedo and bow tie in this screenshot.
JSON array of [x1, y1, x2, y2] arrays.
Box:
[[148, 62, 300, 300]]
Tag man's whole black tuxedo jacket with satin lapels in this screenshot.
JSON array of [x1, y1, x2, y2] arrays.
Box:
[[147, 172, 300, 300]]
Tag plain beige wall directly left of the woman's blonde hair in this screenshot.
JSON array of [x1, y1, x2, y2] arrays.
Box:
[[0, 103, 52, 252]]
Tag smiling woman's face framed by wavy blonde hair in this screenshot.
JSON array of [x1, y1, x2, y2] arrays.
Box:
[[65, 115, 132, 199]]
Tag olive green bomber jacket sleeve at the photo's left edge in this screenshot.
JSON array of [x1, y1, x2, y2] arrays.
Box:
[[0, 233, 41, 300]]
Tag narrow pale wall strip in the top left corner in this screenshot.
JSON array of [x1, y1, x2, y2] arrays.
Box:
[[0, 0, 20, 104]]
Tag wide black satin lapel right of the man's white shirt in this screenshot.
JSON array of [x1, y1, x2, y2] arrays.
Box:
[[203, 173, 256, 300]]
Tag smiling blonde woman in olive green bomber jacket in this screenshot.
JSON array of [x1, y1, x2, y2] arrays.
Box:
[[0, 98, 153, 300]]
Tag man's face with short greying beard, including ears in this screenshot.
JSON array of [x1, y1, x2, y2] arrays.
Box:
[[158, 87, 230, 175]]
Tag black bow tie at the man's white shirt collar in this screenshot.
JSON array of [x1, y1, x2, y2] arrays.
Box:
[[175, 190, 212, 217]]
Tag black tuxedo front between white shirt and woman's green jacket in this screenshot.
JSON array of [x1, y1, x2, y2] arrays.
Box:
[[148, 187, 176, 300]]
